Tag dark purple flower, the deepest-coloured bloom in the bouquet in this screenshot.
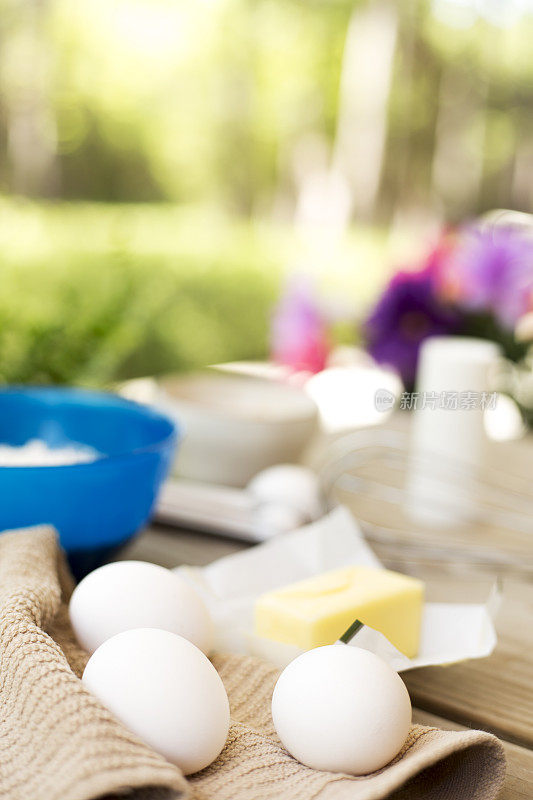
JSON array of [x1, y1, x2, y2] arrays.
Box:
[[364, 260, 461, 387]]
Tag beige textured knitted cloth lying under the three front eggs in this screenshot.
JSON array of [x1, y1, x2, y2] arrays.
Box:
[[0, 527, 505, 800]]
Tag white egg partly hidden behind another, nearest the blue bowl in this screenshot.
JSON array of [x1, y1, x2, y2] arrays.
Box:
[[69, 561, 213, 653]]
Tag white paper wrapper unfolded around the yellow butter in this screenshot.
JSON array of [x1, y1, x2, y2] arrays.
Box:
[[176, 506, 496, 672]]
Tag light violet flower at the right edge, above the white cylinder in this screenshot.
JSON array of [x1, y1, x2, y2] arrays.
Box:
[[443, 227, 533, 329]]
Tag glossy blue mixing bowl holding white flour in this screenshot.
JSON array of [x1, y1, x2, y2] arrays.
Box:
[[0, 387, 178, 577]]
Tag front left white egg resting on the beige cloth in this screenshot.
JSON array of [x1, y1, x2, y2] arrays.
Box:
[[82, 628, 230, 775]]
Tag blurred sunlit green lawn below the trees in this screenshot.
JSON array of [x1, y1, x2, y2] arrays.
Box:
[[0, 199, 394, 386]]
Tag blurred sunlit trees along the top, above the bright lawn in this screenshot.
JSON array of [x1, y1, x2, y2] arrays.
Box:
[[0, 0, 533, 221]]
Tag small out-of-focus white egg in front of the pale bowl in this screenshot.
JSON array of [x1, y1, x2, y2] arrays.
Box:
[[246, 464, 322, 520]]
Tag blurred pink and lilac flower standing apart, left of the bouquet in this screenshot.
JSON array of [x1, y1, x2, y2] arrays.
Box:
[[271, 276, 329, 372]]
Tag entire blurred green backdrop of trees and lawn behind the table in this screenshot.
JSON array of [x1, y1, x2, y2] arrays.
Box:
[[0, 0, 533, 385]]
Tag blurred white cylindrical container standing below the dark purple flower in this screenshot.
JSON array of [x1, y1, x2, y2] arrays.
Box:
[[407, 336, 500, 525]]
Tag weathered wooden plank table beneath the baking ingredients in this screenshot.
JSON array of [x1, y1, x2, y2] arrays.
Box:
[[123, 422, 533, 800]]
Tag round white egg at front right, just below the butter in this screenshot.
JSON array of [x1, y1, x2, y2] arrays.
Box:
[[272, 644, 411, 775]]
